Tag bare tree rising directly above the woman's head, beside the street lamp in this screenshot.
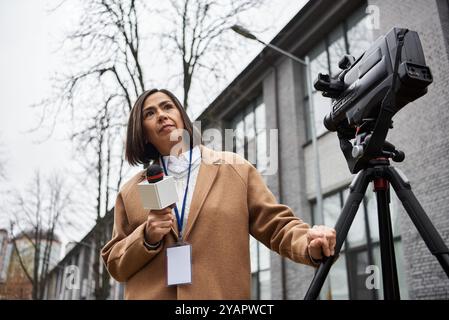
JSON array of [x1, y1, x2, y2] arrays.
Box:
[[161, 0, 264, 109]]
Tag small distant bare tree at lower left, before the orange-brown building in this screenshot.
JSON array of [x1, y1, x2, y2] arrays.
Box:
[[10, 171, 71, 299]]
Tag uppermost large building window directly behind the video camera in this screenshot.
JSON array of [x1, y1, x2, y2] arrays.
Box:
[[303, 6, 374, 140]]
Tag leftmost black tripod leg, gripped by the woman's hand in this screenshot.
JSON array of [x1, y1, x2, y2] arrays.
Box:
[[304, 170, 370, 300]]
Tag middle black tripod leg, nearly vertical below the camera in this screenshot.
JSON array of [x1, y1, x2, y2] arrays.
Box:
[[374, 178, 400, 300]]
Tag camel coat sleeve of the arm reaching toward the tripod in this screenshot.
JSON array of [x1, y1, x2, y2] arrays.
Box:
[[247, 165, 317, 267]]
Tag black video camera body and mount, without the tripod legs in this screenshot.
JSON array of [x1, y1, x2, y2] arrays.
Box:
[[314, 28, 433, 173]]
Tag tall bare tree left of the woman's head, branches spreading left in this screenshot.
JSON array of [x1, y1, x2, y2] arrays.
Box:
[[34, 0, 144, 185]]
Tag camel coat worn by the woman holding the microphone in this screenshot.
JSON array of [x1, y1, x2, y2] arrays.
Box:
[[102, 146, 313, 299]]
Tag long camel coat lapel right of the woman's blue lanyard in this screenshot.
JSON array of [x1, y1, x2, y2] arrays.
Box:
[[184, 146, 221, 239]]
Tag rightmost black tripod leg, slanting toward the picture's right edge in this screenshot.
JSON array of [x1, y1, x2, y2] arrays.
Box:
[[387, 167, 449, 277]]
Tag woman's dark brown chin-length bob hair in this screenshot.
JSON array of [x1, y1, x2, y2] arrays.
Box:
[[125, 89, 201, 165]]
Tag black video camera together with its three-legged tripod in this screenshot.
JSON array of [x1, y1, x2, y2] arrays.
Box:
[[304, 28, 449, 300]]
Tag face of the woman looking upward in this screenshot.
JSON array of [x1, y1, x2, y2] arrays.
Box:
[[142, 92, 184, 155]]
